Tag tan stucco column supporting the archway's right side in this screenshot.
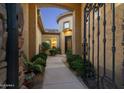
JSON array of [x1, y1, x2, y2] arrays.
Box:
[[72, 7, 82, 55]]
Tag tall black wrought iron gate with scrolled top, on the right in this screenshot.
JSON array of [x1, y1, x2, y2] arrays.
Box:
[[83, 3, 117, 88]]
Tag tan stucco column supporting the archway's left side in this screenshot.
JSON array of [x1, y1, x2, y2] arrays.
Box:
[[29, 4, 36, 58]]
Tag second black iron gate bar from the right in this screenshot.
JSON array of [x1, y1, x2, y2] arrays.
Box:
[[103, 4, 106, 76]]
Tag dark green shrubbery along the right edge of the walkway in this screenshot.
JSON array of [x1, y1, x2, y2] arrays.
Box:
[[66, 53, 95, 78]]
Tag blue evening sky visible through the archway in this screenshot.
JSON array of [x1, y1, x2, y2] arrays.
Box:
[[40, 7, 67, 29]]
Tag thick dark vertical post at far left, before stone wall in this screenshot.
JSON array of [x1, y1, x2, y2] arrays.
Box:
[[6, 4, 19, 89]]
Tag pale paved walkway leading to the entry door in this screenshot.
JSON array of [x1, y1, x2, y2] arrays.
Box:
[[43, 56, 87, 89]]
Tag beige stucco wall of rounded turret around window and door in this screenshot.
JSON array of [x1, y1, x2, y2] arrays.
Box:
[[58, 15, 73, 54]]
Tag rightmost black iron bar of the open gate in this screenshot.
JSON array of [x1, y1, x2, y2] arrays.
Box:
[[112, 4, 116, 82]]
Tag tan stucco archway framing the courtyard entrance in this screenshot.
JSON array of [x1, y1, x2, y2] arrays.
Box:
[[29, 3, 81, 58]]
